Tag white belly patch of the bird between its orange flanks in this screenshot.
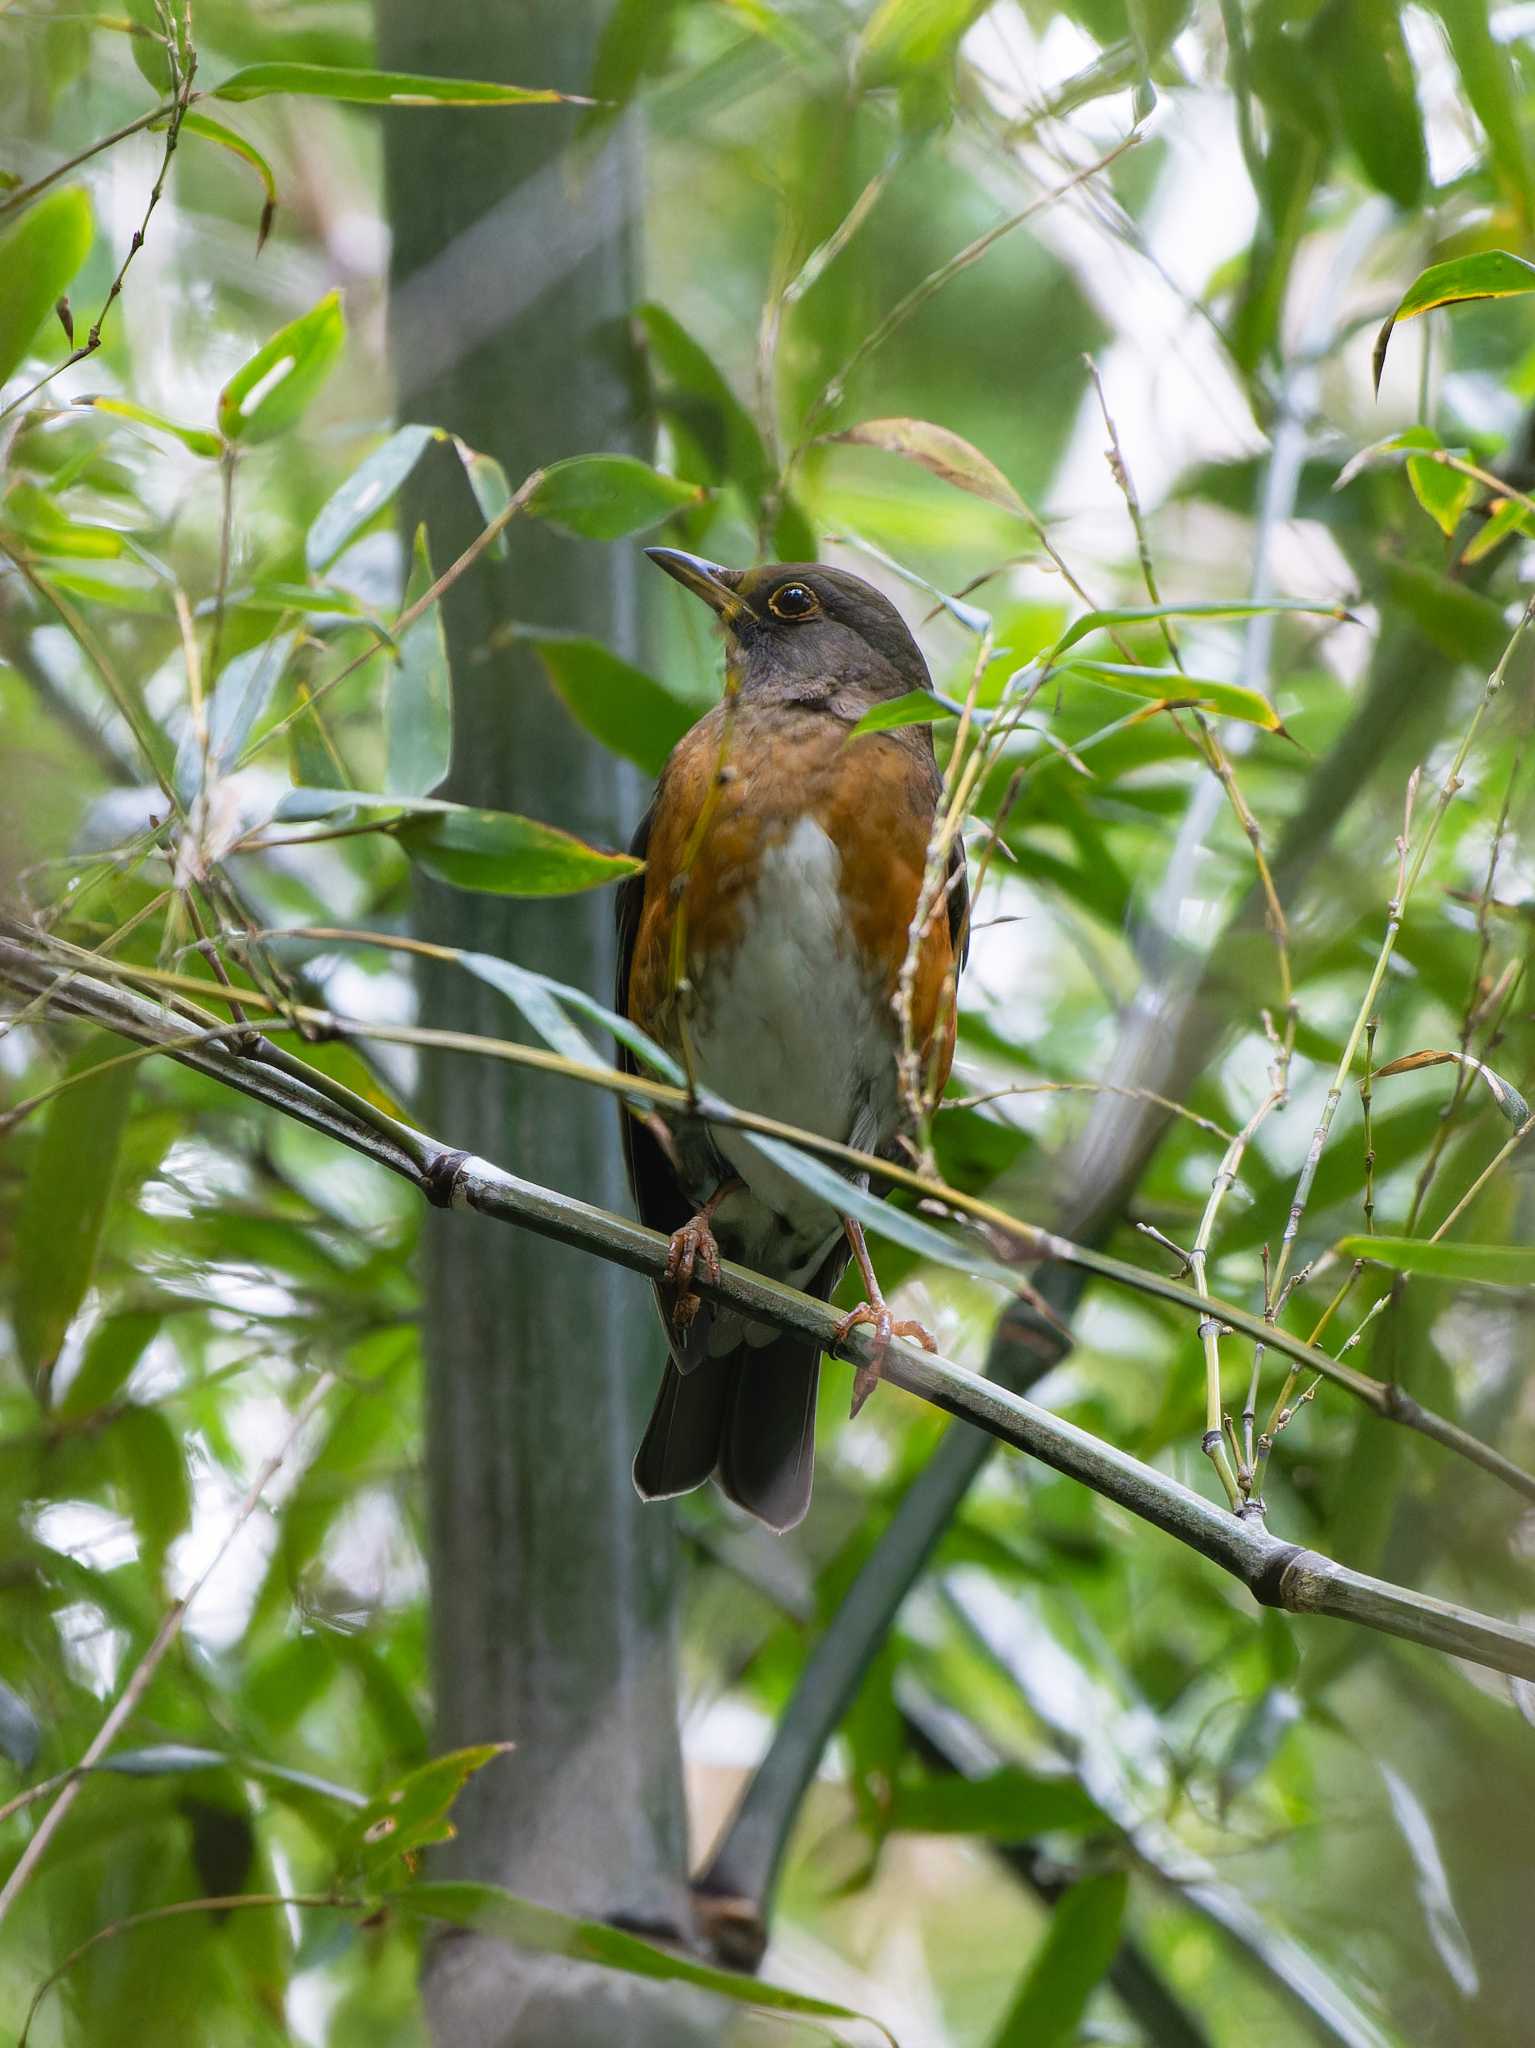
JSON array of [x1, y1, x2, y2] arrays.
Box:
[[690, 817, 898, 1272]]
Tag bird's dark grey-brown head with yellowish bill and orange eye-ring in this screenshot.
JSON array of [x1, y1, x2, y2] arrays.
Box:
[[645, 547, 933, 698]]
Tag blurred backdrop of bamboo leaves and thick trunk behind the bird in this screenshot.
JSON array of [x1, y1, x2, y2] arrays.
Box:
[[0, 0, 1535, 2048]]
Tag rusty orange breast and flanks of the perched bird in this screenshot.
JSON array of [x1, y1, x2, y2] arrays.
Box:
[[628, 700, 956, 1114]]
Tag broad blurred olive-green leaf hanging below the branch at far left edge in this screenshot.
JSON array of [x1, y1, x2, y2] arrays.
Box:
[[14, 1032, 139, 1389]]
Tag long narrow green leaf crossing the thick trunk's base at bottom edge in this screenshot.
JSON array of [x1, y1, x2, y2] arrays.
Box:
[[383, 1882, 894, 2048]]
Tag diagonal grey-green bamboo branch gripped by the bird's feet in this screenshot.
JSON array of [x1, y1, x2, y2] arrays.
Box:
[[0, 940, 1535, 1687]]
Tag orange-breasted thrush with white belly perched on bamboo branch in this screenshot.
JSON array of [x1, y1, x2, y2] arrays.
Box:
[[614, 547, 970, 1532]]
